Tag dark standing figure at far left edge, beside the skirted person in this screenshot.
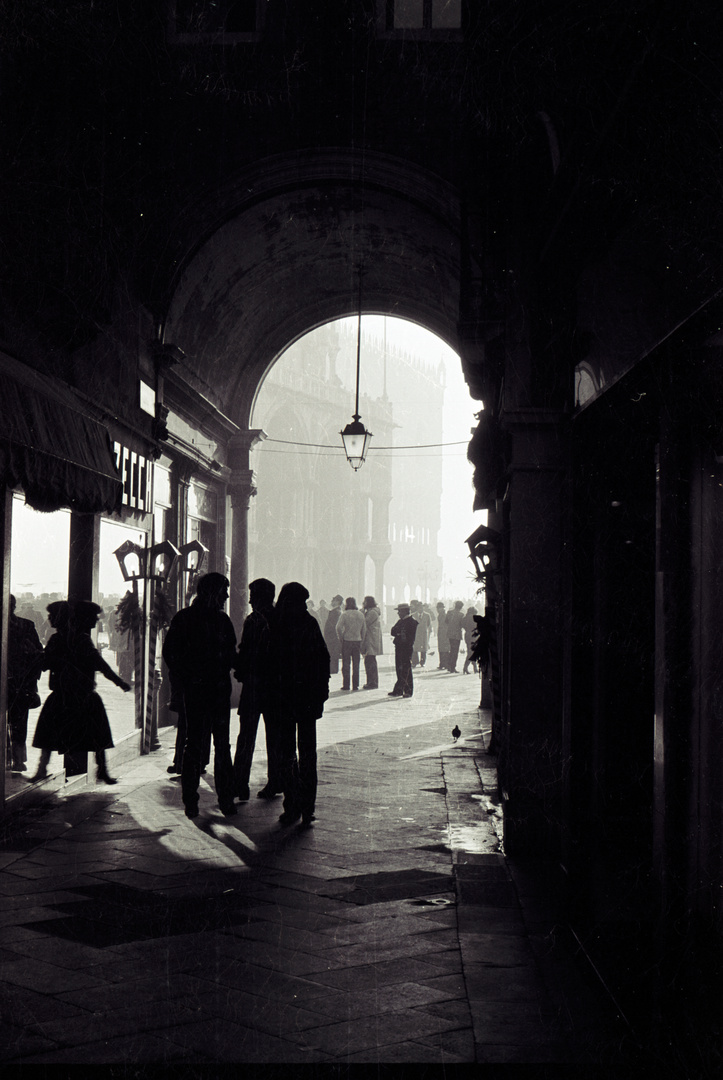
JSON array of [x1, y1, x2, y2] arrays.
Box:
[[8, 596, 42, 772]]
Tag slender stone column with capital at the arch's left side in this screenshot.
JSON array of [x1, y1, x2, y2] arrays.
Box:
[[228, 428, 267, 637]]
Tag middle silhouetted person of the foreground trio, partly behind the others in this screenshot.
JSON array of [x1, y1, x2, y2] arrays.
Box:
[[233, 578, 281, 802]]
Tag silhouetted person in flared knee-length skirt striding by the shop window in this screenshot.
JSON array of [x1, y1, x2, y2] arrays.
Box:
[[32, 600, 131, 784]]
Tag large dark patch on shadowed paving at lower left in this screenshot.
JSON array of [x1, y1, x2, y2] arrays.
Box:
[[15, 885, 259, 948]]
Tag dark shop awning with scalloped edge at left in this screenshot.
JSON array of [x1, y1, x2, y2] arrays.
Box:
[[0, 357, 122, 513]]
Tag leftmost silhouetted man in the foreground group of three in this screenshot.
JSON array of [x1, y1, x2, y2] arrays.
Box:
[[163, 572, 237, 818]]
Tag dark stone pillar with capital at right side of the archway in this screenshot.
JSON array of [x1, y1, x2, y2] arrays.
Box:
[[499, 408, 566, 854]]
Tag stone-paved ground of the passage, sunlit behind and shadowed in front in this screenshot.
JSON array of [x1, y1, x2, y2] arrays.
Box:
[[0, 659, 626, 1066]]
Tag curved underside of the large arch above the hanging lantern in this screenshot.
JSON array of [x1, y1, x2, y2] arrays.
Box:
[[164, 152, 460, 427]]
